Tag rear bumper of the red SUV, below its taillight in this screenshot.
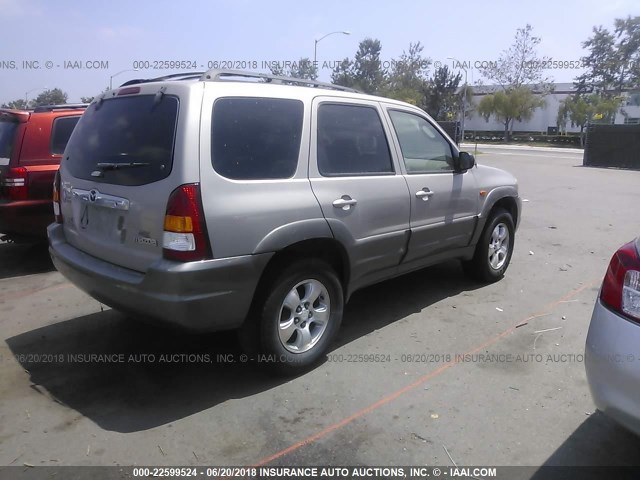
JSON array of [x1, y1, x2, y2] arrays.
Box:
[[0, 199, 54, 238]]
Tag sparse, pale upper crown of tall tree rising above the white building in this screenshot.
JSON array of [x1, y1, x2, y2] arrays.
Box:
[[479, 24, 550, 91]]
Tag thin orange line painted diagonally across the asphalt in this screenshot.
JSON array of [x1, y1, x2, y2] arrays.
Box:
[[253, 279, 601, 467]]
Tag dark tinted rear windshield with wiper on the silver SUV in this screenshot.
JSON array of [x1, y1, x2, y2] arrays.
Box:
[[64, 95, 178, 185]]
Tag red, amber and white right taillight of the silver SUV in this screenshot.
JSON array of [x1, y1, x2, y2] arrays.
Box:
[[162, 183, 211, 262]]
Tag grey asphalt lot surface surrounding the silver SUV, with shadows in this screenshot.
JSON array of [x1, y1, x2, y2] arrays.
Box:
[[0, 146, 640, 474]]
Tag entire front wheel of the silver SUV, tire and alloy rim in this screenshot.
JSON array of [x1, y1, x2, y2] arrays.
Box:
[[464, 208, 514, 282]]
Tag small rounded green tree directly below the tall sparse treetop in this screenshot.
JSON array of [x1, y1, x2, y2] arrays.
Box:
[[477, 87, 545, 141]]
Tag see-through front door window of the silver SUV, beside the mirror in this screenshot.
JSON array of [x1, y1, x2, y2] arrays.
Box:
[[389, 110, 453, 173]]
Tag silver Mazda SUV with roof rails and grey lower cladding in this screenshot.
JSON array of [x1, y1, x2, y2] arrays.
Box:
[[48, 70, 521, 372]]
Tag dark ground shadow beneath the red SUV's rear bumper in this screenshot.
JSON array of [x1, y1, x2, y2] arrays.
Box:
[[0, 240, 55, 279]]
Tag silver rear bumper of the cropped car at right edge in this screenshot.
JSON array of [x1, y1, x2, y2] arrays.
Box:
[[585, 299, 640, 435]]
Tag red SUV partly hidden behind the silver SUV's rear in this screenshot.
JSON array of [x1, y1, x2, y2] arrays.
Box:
[[0, 104, 87, 241]]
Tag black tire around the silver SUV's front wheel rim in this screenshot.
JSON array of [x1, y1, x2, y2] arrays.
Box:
[[463, 208, 515, 283]]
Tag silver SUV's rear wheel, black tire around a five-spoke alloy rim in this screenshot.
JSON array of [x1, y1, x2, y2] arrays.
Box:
[[256, 259, 344, 375]]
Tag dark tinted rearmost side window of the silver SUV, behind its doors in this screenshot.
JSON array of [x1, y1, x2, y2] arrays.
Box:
[[211, 97, 304, 180]]
